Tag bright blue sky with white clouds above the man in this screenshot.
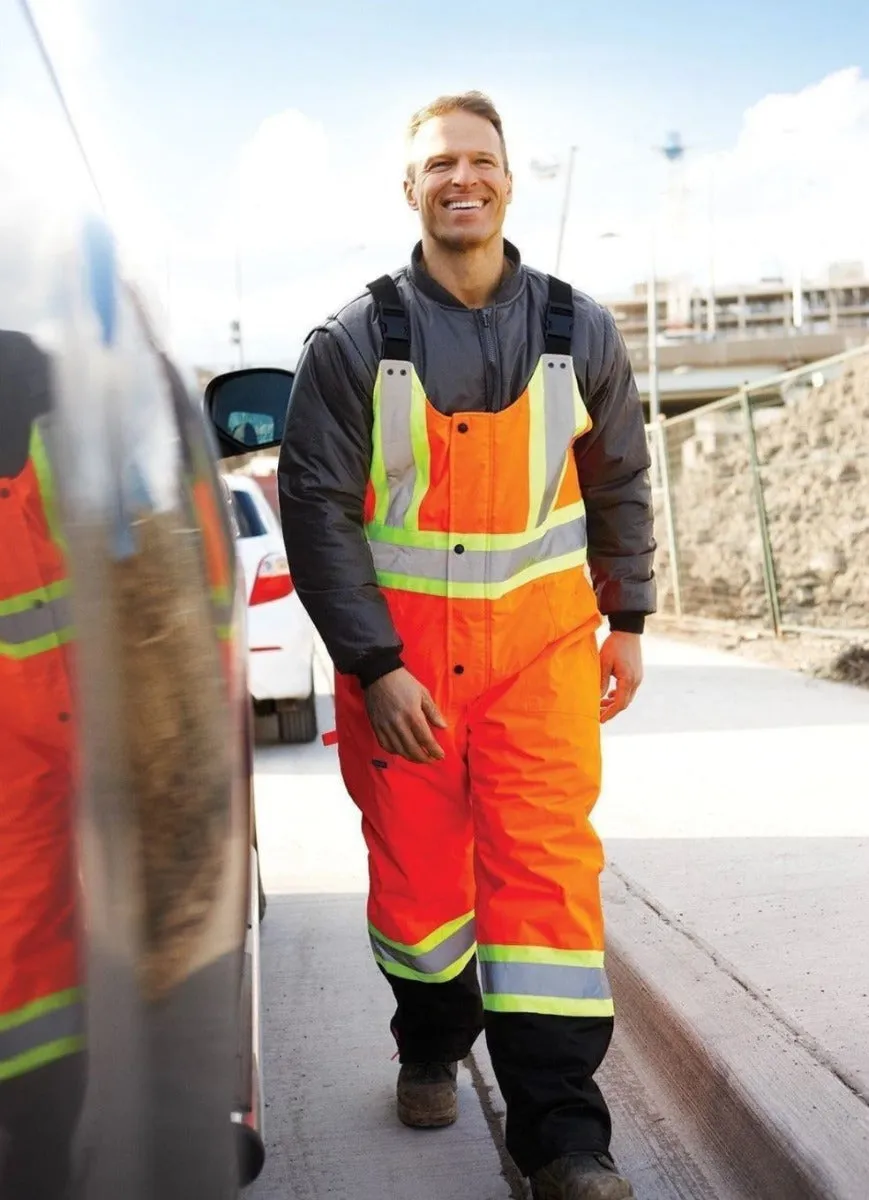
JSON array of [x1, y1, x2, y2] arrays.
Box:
[[23, 0, 869, 368]]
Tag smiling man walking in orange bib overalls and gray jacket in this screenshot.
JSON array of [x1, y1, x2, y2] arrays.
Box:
[[278, 92, 654, 1200]]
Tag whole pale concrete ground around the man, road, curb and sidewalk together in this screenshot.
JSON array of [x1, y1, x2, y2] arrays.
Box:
[[250, 638, 869, 1200]]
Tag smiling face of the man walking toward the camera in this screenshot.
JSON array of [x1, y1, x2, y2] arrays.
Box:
[[404, 110, 513, 250]]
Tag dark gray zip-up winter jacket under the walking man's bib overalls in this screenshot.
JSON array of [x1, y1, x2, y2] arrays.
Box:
[[278, 244, 655, 684]]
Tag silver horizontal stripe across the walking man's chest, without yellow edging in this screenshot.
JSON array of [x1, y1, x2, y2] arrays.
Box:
[[371, 515, 586, 583]]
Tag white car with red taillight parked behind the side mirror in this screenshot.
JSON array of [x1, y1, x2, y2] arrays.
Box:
[[223, 474, 317, 742]]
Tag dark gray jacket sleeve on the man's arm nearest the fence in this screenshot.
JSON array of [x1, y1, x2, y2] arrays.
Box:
[[576, 310, 655, 632]]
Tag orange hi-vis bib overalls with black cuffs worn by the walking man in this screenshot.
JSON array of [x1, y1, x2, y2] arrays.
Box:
[[336, 278, 613, 1172]]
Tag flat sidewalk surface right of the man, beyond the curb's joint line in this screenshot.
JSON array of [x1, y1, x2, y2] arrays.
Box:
[[595, 640, 869, 1100]]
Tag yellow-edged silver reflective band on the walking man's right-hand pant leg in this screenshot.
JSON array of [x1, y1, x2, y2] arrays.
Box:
[[479, 946, 613, 1016]]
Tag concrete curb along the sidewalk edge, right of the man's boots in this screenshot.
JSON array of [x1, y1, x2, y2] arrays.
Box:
[[604, 866, 869, 1200]]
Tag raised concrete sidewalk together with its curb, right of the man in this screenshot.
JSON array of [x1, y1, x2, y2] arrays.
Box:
[[595, 640, 869, 1200]]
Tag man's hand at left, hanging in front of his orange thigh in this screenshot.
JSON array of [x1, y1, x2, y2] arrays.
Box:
[[365, 667, 447, 763]]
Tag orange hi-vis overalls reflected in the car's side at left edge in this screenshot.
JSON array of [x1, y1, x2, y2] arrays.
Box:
[[0, 421, 83, 1081]]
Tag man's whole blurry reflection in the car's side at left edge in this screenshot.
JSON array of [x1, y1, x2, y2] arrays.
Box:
[[0, 331, 84, 1200]]
